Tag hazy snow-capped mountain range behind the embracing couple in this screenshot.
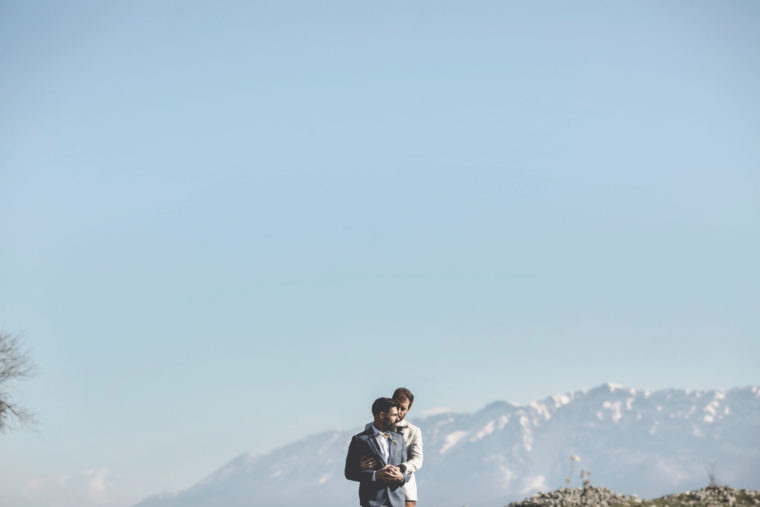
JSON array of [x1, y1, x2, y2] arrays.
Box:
[[136, 384, 760, 507]]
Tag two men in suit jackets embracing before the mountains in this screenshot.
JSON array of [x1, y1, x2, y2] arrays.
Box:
[[346, 387, 422, 507]]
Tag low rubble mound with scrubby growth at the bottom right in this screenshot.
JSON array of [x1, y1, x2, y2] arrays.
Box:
[[507, 486, 760, 507]]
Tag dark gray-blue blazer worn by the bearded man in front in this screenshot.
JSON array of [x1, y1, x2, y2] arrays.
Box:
[[345, 427, 410, 507]]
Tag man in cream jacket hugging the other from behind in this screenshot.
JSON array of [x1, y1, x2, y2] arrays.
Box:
[[361, 387, 422, 507]]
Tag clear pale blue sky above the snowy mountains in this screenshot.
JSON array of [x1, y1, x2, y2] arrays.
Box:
[[0, 0, 760, 507]]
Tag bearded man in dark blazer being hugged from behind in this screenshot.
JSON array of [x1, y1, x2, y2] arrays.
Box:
[[345, 398, 410, 507]]
